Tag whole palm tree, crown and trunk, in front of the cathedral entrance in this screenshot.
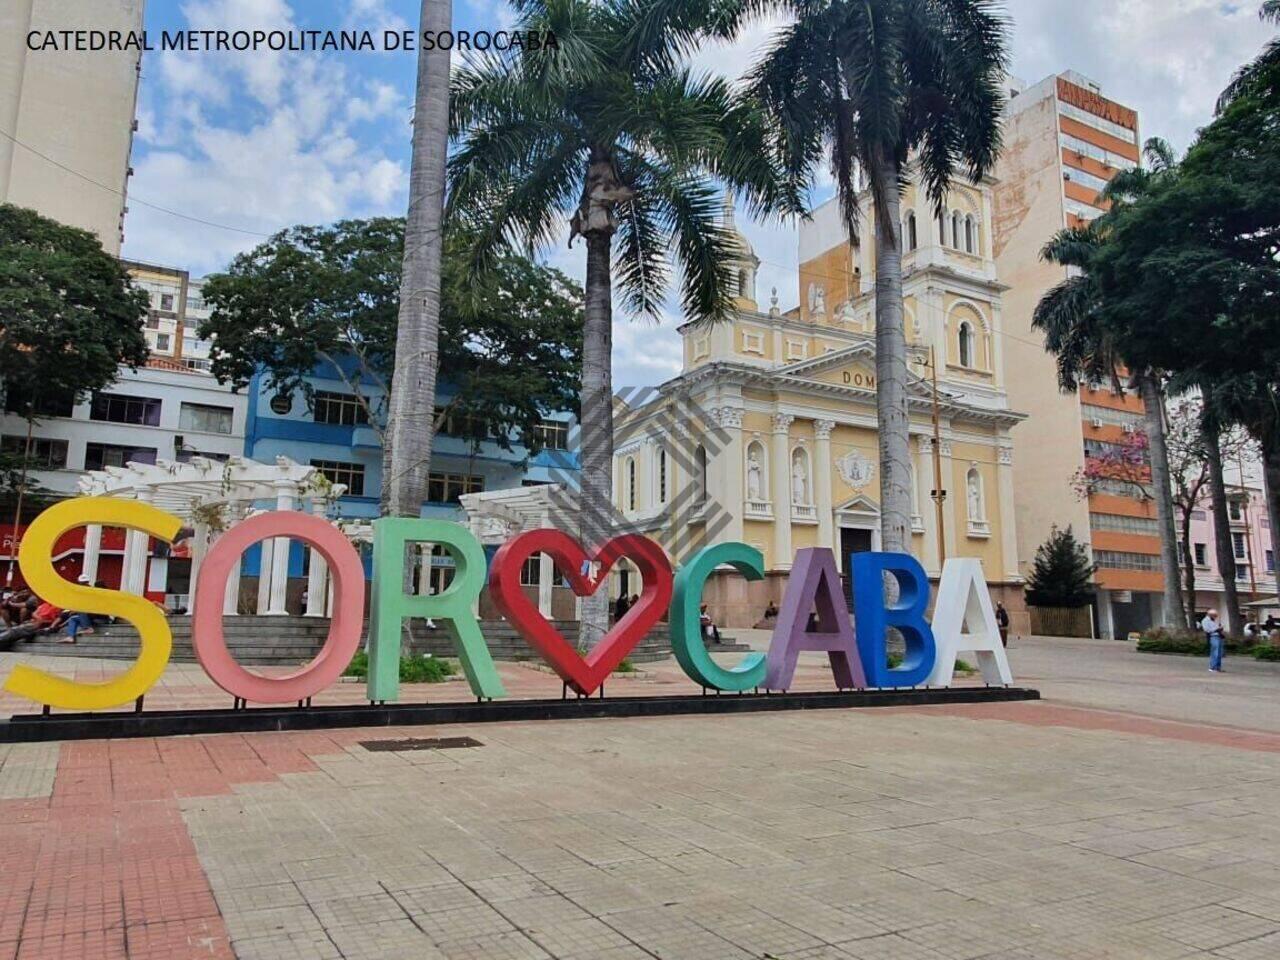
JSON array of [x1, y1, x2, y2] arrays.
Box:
[[739, 0, 1007, 550]]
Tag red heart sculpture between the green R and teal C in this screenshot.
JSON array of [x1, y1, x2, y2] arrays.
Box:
[[489, 530, 671, 696]]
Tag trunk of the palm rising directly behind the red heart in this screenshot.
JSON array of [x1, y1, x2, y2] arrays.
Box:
[[579, 229, 613, 650]]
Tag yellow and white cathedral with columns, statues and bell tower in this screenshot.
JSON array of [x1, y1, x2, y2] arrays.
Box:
[[613, 174, 1023, 627]]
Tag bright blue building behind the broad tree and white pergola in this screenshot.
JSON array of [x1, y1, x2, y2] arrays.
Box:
[[244, 364, 580, 579]]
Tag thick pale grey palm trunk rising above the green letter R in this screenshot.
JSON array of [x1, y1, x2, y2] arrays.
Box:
[[383, 0, 453, 517]]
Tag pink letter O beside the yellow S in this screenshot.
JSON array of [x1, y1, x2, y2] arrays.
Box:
[[191, 511, 365, 703]]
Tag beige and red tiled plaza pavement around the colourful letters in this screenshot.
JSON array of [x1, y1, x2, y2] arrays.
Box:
[[0, 640, 1280, 960]]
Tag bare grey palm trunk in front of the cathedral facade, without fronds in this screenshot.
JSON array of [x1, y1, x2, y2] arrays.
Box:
[[872, 159, 911, 553]]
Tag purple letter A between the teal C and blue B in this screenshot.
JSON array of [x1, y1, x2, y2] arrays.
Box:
[[764, 547, 867, 690]]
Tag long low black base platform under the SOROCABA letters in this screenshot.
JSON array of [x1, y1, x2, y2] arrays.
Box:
[[0, 686, 1039, 744]]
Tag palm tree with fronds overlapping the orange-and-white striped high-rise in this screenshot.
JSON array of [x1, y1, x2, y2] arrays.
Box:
[[1032, 137, 1187, 627]]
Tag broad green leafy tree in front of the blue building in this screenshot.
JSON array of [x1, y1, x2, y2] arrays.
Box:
[[200, 218, 582, 465]]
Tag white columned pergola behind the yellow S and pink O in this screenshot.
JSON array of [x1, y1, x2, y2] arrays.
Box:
[[79, 457, 346, 617]]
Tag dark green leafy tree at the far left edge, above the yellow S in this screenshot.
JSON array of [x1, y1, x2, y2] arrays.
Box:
[[0, 204, 147, 580]]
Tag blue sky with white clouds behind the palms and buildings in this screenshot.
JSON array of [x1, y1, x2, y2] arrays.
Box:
[[124, 0, 1272, 388]]
